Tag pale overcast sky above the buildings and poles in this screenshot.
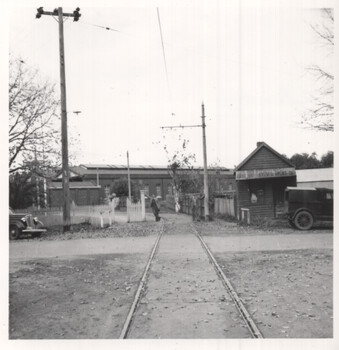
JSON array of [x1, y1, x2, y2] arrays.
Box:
[[5, 1, 334, 167]]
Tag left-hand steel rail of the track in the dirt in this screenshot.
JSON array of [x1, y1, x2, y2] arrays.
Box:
[[119, 221, 165, 339]]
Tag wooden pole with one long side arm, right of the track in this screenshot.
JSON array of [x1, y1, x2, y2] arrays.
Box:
[[161, 103, 210, 221]]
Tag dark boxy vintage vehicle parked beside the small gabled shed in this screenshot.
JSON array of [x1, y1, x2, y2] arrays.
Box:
[[284, 187, 333, 230]]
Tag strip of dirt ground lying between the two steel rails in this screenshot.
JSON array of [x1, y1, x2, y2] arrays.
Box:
[[128, 217, 251, 339]]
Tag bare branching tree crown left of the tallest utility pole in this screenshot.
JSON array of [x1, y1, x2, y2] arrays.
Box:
[[9, 58, 61, 175]]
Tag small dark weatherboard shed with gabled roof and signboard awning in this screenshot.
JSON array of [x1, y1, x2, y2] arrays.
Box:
[[235, 142, 296, 221]]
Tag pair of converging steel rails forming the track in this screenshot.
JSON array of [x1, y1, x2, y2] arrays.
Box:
[[119, 220, 263, 339]]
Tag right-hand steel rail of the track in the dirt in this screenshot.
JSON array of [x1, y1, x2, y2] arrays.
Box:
[[191, 224, 264, 338]]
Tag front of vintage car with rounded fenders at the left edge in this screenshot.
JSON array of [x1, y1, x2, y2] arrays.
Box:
[[9, 208, 46, 239]]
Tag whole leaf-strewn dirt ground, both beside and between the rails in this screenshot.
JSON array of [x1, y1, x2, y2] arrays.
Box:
[[9, 214, 333, 339]]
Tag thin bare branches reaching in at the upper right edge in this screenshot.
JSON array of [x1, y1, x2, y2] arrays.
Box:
[[302, 8, 334, 131]]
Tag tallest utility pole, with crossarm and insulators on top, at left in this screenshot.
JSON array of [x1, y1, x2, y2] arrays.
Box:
[[36, 7, 81, 232]]
